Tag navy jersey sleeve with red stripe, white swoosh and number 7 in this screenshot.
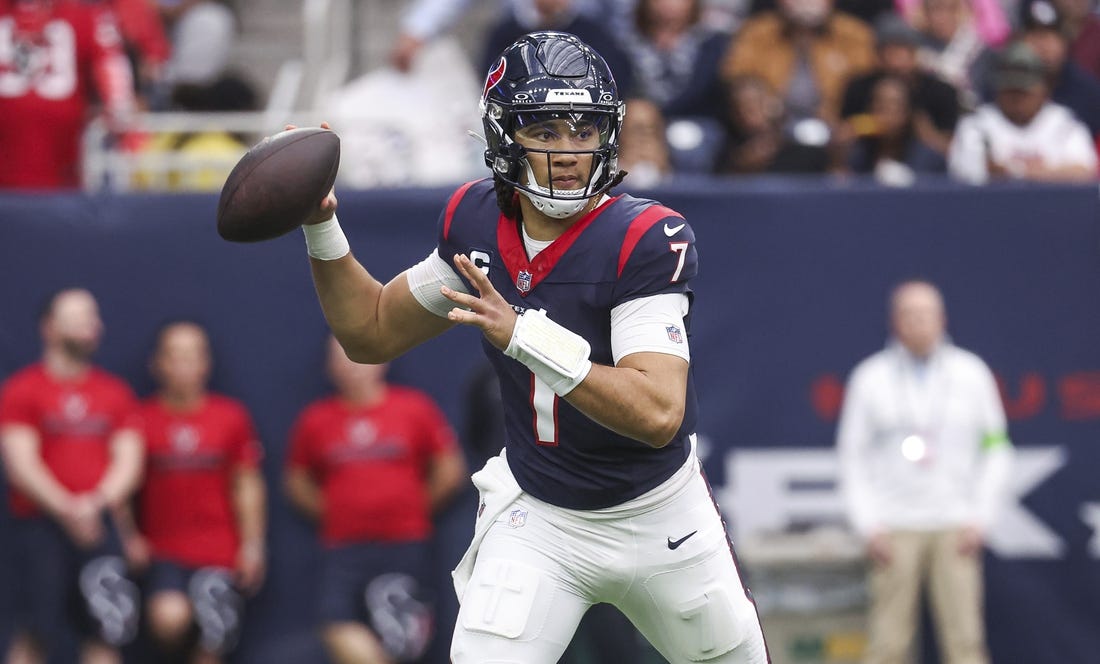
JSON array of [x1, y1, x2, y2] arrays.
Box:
[[614, 206, 699, 305]]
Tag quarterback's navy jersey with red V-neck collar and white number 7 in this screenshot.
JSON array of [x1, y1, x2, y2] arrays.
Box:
[[439, 179, 697, 509]]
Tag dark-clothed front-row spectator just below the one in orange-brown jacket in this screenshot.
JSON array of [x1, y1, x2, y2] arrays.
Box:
[[715, 76, 829, 175]]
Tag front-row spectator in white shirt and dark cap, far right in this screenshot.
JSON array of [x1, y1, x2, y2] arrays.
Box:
[[948, 43, 1097, 184]]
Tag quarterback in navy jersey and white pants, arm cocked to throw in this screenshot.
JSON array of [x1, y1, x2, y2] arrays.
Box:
[[304, 32, 770, 664]]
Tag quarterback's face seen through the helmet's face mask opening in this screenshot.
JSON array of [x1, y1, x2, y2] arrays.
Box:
[[515, 113, 603, 191]]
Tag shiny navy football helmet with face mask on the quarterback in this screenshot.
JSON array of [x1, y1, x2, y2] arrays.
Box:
[[481, 32, 625, 219]]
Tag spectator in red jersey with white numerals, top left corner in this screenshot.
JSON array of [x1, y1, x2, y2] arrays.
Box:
[[0, 0, 134, 189]]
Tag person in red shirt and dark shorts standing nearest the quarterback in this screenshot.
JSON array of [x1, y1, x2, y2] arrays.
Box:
[[285, 339, 466, 664]]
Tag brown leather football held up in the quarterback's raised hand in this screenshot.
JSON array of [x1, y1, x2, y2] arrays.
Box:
[[218, 128, 340, 242]]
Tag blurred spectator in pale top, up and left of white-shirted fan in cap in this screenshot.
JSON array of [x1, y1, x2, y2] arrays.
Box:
[[910, 0, 993, 110]]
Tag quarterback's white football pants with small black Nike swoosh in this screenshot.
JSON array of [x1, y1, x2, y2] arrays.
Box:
[[451, 453, 769, 664]]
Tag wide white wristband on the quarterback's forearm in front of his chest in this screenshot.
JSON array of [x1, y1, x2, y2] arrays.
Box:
[[504, 309, 592, 397]]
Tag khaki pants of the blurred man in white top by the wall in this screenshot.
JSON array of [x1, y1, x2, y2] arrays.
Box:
[[865, 530, 989, 664]]
